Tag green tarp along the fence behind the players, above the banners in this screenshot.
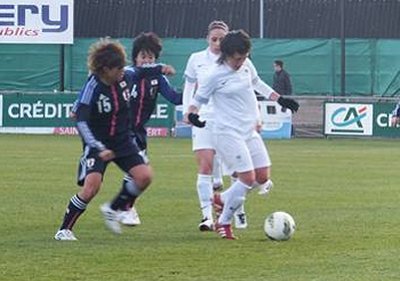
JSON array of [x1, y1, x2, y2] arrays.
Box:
[[0, 39, 400, 96]]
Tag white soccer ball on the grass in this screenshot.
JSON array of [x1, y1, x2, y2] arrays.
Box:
[[264, 212, 296, 241]]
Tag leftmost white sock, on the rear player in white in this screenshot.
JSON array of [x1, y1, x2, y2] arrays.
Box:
[[197, 174, 213, 219]]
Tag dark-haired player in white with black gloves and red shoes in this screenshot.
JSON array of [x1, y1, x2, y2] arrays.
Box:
[[188, 30, 299, 239]]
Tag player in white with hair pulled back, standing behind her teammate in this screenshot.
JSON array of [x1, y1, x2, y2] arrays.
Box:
[[183, 21, 229, 231]]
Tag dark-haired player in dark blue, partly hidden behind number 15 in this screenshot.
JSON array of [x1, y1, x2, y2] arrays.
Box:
[[119, 32, 182, 226]]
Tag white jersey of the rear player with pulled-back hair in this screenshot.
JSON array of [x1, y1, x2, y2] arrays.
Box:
[[183, 48, 219, 120]]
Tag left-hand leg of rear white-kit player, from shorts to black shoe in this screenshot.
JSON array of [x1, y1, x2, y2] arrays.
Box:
[[192, 126, 215, 231]]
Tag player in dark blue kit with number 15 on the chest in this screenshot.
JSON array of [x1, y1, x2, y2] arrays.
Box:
[[54, 38, 171, 238]]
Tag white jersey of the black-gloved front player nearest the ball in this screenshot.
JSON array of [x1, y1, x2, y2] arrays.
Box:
[[191, 59, 274, 138]]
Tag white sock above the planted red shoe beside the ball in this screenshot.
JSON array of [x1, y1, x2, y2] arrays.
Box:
[[218, 180, 250, 224]]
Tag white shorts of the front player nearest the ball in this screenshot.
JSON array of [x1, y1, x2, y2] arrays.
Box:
[[214, 132, 271, 174]]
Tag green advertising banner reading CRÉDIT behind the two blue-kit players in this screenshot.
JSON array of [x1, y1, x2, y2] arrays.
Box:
[[0, 94, 175, 135]]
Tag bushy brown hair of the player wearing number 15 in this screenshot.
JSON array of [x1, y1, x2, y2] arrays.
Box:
[[87, 37, 126, 75]]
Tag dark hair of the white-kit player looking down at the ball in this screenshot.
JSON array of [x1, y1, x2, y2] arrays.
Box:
[[218, 29, 251, 63]]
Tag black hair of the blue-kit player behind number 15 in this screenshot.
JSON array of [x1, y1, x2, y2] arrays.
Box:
[[132, 32, 162, 64]]
